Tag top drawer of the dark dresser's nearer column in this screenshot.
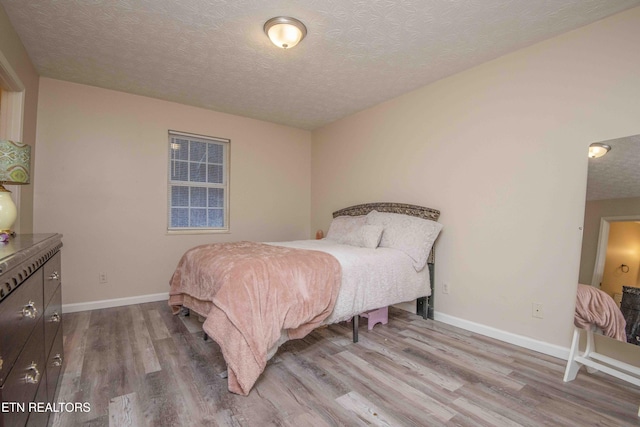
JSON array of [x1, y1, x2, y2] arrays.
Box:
[[0, 269, 44, 386]]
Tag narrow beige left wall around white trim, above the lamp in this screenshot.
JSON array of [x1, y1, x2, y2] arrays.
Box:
[[0, 6, 39, 233]]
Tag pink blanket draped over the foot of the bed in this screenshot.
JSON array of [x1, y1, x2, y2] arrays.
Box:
[[169, 242, 341, 396]]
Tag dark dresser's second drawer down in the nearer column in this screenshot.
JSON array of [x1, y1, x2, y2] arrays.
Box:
[[1, 316, 46, 426]]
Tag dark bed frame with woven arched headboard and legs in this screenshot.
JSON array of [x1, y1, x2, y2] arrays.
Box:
[[333, 202, 440, 342]]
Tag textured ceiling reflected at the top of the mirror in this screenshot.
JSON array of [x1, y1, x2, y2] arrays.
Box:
[[585, 135, 640, 200]]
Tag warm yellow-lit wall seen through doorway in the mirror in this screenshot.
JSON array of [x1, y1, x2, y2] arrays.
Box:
[[600, 222, 640, 297]]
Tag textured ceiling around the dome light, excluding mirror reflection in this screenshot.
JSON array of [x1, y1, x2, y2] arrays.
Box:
[[0, 0, 640, 129]]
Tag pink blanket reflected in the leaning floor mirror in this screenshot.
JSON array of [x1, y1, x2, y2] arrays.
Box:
[[573, 284, 627, 341]]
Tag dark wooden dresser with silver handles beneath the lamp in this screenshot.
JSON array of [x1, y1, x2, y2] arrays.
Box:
[[0, 234, 63, 427]]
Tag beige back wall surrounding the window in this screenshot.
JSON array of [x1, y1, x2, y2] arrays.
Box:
[[35, 78, 311, 303]]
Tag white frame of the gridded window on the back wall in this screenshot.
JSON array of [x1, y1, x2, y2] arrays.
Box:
[[167, 130, 231, 234]]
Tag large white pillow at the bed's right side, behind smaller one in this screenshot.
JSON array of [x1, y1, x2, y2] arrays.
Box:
[[366, 211, 442, 271]]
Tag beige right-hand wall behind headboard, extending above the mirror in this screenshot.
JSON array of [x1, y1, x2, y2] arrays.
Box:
[[311, 8, 640, 347]]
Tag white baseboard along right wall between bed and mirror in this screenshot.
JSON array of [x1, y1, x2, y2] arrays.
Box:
[[434, 312, 569, 360]]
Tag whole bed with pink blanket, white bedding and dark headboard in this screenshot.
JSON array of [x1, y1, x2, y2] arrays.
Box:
[[169, 203, 442, 395]]
